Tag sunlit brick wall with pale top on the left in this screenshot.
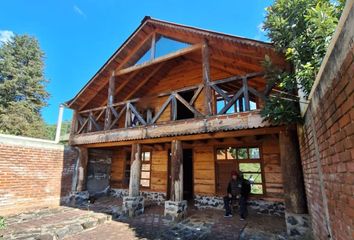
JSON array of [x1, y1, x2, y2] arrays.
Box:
[[0, 135, 77, 215]]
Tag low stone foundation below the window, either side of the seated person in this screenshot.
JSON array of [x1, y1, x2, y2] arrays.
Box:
[[194, 195, 285, 216]]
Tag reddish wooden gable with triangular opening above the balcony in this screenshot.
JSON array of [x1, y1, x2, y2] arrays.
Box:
[[67, 17, 285, 110]]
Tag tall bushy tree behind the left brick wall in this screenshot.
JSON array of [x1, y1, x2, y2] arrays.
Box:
[[0, 35, 49, 137]]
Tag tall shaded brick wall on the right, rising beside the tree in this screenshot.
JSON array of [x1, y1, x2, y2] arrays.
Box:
[[299, 1, 354, 240]]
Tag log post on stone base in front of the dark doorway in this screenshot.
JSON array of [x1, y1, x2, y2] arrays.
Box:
[[165, 140, 187, 220]]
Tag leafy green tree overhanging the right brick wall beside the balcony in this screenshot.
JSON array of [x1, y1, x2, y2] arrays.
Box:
[[261, 0, 345, 124]]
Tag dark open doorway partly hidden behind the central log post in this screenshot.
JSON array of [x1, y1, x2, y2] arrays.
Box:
[[167, 149, 193, 200]]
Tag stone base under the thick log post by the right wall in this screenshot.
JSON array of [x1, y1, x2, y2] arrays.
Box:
[[285, 212, 312, 239]]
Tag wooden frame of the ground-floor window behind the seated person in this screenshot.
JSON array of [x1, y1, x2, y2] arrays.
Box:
[[214, 144, 267, 198]]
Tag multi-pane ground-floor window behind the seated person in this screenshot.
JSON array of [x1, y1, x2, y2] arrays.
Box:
[[216, 147, 264, 195]]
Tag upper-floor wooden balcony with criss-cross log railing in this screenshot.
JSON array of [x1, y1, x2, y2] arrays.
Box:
[[71, 73, 269, 145]]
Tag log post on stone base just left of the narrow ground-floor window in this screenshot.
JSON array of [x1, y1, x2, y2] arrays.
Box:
[[123, 144, 144, 217]]
